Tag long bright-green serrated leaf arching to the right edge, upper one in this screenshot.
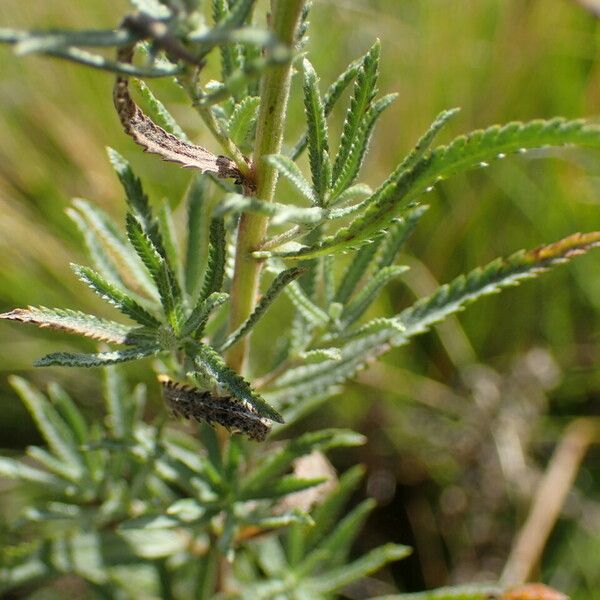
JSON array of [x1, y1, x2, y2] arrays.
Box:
[[262, 118, 600, 259]]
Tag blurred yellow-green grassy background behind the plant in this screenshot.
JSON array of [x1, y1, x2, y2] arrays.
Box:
[[0, 0, 600, 600]]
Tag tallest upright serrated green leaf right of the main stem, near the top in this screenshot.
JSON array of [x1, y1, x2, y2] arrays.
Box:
[[333, 40, 381, 186]]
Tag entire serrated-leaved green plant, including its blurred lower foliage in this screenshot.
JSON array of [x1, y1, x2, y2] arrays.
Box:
[[0, 0, 600, 600]]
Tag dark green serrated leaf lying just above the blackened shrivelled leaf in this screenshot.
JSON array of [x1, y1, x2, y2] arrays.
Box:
[[189, 343, 283, 423]]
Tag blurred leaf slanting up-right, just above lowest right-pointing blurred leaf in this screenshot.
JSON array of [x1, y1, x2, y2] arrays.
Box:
[[297, 498, 376, 574]]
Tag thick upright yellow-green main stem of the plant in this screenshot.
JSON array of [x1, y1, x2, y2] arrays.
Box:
[[227, 0, 305, 372]]
